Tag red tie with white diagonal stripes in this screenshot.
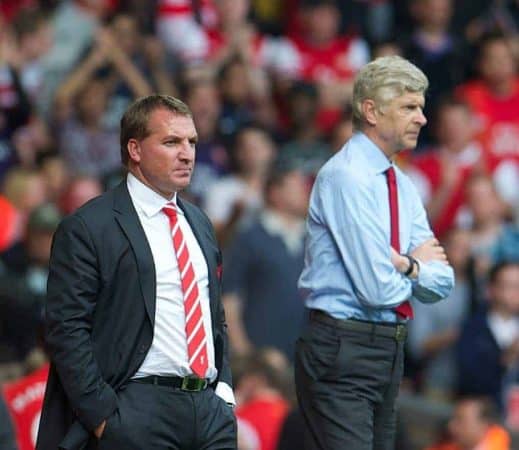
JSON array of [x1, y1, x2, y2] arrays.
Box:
[[162, 203, 208, 378]]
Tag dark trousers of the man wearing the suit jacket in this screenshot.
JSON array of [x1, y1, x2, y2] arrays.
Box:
[[97, 381, 237, 450]]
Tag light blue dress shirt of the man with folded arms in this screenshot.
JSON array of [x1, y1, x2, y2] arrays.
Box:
[[299, 133, 454, 322]]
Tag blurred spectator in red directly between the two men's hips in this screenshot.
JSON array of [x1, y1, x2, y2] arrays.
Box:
[[234, 349, 290, 450]]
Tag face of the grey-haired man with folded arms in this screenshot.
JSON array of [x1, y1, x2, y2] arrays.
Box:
[[373, 92, 427, 156]]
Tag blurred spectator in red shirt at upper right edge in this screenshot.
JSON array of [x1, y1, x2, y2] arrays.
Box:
[[457, 33, 519, 163]]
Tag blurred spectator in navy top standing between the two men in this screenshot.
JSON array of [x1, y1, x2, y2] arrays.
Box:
[[223, 169, 308, 361]]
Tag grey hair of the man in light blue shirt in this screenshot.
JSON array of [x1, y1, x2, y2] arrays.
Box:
[[352, 56, 429, 129]]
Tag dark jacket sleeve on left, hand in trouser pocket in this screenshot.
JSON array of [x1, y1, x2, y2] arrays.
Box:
[[45, 215, 117, 430]]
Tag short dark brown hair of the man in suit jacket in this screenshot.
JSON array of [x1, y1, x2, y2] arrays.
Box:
[[120, 94, 193, 166]]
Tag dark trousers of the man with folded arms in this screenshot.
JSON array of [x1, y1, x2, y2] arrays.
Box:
[[295, 313, 405, 450]]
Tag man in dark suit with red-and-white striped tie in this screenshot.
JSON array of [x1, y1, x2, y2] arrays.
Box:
[[37, 95, 236, 450]]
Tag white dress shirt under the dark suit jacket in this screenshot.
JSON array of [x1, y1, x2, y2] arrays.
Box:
[[127, 174, 235, 404]]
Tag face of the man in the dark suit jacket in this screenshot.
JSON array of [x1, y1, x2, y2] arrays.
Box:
[[128, 108, 198, 199]]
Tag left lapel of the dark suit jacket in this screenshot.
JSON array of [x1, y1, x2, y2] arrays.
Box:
[[114, 180, 156, 326]]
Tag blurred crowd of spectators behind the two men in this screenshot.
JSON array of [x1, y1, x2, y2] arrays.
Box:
[[0, 0, 519, 450]]
